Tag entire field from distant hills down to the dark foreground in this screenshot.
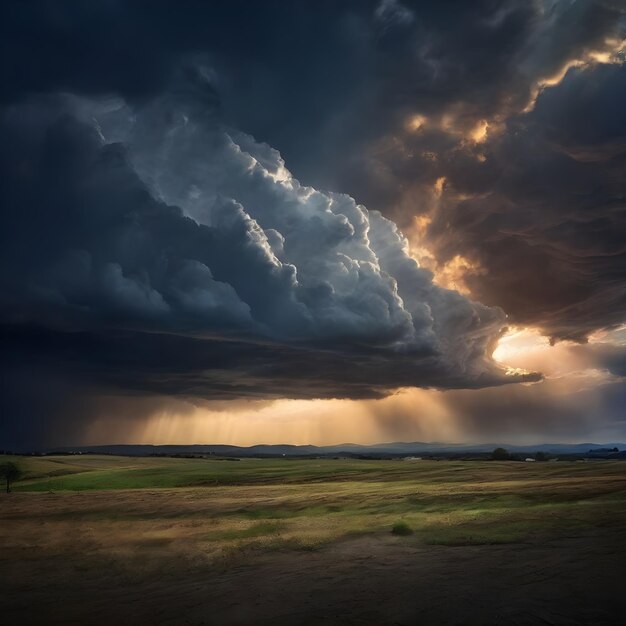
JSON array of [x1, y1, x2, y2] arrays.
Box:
[[0, 455, 626, 624]]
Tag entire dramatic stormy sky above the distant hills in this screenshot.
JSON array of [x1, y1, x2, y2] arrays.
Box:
[[0, 0, 626, 450]]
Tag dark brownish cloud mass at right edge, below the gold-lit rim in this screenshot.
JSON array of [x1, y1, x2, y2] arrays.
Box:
[[429, 65, 626, 340]]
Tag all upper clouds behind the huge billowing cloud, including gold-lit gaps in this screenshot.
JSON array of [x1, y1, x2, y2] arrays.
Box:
[[0, 0, 626, 340]]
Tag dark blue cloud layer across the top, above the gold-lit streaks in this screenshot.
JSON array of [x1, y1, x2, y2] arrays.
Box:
[[0, 0, 621, 163]]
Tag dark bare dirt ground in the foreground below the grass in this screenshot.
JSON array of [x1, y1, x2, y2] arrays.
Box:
[[1, 512, 626, 626]]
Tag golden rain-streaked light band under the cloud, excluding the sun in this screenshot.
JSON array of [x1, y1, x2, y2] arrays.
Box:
[[82, 389, 459, 446]]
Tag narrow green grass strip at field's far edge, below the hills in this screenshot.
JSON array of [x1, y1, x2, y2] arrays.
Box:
[[8, 455, 623, 492]]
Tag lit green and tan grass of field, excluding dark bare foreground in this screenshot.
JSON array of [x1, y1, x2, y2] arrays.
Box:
[[3, 455, 626, 559]]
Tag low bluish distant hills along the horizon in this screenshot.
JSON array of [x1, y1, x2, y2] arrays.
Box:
[[15, 441, 626, 457]]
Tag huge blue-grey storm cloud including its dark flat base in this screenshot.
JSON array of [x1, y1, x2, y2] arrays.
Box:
[[0, 86, 520, 445]]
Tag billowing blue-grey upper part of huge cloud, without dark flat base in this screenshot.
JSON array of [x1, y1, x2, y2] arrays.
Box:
[[2, 88, 504, 354]]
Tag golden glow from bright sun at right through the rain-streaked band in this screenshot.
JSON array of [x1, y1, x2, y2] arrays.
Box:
[[81, 327, 626, 446]]
